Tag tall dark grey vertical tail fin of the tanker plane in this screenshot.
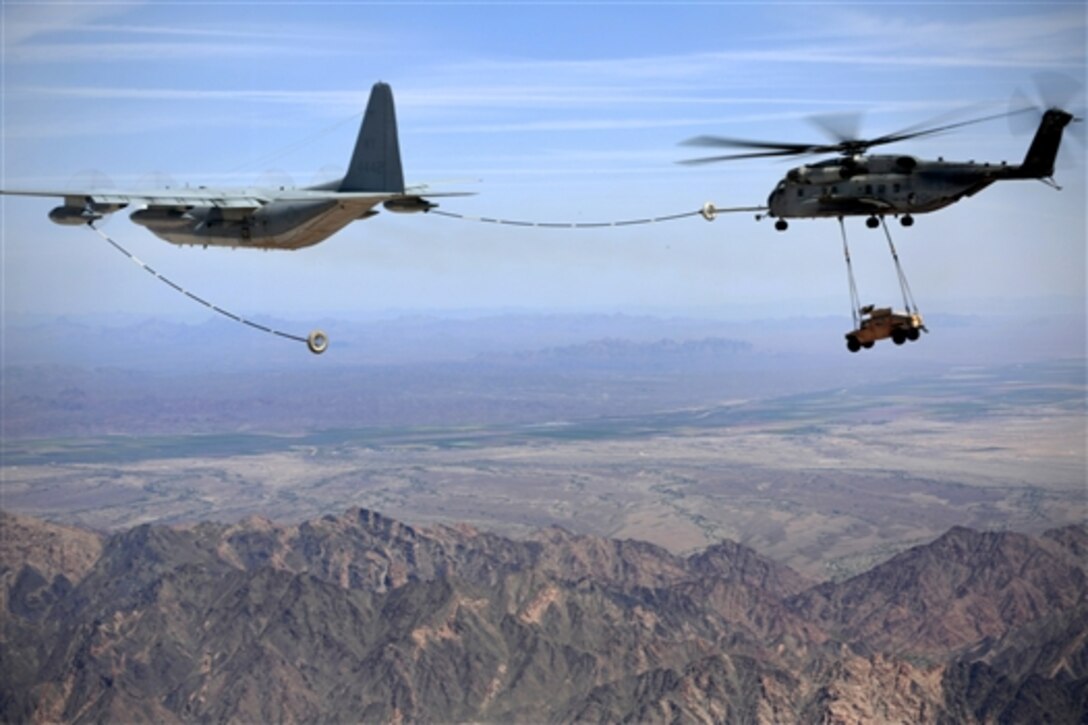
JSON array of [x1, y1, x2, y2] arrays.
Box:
[[339, 83, 405, 194]]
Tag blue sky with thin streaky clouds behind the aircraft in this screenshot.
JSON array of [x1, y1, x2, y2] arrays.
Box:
[[0, 1, 1086, 321]]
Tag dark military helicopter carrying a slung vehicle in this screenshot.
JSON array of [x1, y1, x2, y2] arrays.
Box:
[[681, 107, 1079, 232]]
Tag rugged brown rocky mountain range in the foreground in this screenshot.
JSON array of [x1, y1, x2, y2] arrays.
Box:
[[0, 509, 1088, 723]]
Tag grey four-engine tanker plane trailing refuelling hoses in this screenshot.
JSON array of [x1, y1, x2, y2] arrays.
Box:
[[0, 83, 467, 249]]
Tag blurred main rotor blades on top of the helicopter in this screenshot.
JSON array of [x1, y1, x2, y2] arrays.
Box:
[[680, 106, 1023, 164]]
